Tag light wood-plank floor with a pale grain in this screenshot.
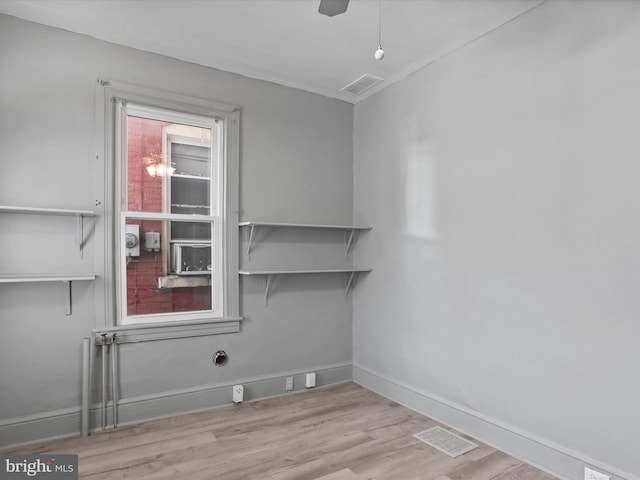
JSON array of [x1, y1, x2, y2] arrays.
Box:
[[10, 383, 554, 480]]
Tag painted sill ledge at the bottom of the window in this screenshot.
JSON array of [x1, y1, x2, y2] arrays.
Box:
[[93, 318, 242, 345]]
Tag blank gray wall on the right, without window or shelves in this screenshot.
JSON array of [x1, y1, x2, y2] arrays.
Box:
[[354, 1, 640, 479]]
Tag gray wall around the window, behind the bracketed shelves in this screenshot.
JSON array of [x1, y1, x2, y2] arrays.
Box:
[[0, 12, 353, 445]]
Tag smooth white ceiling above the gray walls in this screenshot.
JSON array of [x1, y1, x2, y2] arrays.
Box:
[[0, 0, 546, 103]]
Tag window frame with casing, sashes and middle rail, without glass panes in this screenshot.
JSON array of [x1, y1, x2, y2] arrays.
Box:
[[94, 80, 241, 342]]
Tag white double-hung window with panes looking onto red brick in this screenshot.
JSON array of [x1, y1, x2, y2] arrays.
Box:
[[104, 85, 238, 334]]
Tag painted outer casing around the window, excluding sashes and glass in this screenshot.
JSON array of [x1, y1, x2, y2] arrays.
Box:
[[94, 80, 241, 341]]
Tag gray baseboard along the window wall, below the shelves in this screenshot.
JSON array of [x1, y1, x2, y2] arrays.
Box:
[[0, 363, 352, 450]]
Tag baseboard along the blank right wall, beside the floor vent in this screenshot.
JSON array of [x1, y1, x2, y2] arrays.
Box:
[[353, 365, 638, 480]]
